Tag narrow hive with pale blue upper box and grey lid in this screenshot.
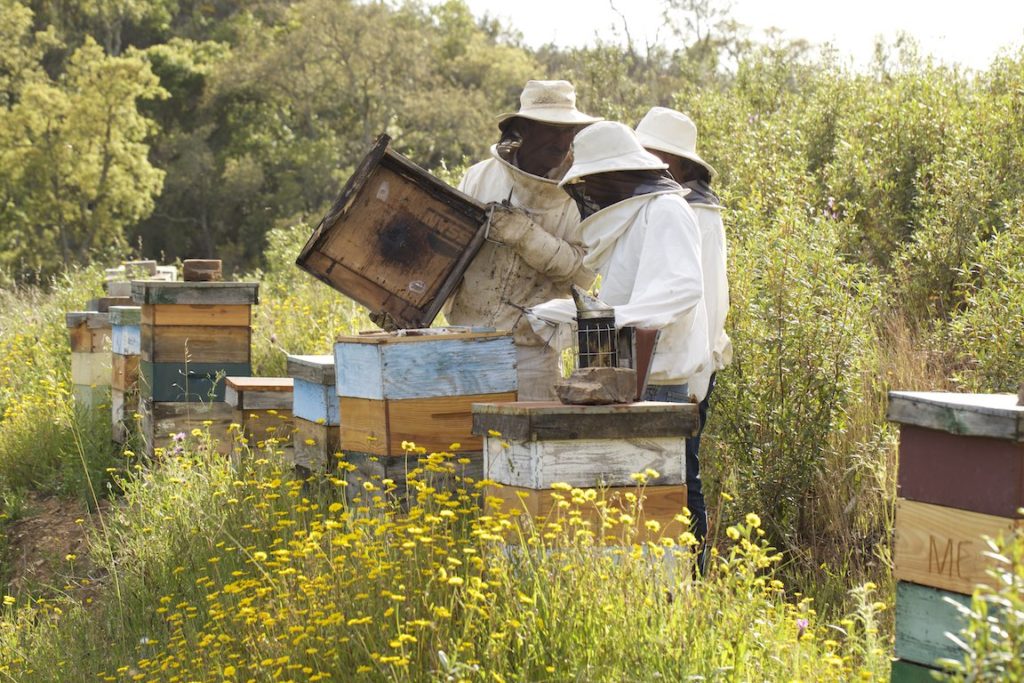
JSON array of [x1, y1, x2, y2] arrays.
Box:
[[288, 355, 341, 476]]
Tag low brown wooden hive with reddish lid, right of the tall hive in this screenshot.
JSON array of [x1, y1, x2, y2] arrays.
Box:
[[224, 377, 294, 451]]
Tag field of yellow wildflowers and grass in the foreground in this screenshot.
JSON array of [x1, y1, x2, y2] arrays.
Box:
[[0, 435, 888, 681]]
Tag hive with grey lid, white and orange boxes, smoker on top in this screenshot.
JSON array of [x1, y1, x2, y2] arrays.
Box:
[[473, 401, 697, 538]]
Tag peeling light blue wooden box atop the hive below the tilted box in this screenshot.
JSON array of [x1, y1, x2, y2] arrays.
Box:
[[335, 333, 517, 398]]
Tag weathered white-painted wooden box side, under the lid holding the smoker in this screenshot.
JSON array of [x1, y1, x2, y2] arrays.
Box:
[[483, 436, 686, 488]]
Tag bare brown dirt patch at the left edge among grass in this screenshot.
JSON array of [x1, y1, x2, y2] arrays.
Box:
[[0, 494, 110, 595]]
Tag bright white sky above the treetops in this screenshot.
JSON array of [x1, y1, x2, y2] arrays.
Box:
[[454, 0, 1024, 69]]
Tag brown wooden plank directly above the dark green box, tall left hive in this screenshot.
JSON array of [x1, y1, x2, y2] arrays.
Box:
[[141, 325, 251, 364]]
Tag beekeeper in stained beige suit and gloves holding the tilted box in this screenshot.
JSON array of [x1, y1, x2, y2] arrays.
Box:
[[444, 81, 600, 400]]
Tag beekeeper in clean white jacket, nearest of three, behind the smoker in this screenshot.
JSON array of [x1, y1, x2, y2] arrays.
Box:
[[561, 121, 712, 565]]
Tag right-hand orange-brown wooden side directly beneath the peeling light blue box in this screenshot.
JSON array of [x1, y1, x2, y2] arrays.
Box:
[[387, 392, 515, 455]]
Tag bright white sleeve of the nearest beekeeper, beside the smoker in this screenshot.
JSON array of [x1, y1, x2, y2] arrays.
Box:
[[615, 201, 703, 330]]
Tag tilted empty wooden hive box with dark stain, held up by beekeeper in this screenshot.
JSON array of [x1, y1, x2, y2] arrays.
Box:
[[296, 135, 486, 329]]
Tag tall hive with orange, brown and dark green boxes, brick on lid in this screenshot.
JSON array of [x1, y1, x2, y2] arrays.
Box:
[[132, 281, 259, 455]]
